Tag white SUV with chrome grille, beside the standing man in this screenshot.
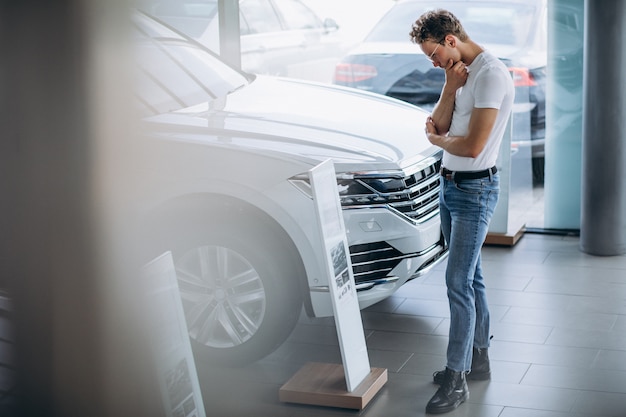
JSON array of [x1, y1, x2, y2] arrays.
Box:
[[135, 13, 447, 363]]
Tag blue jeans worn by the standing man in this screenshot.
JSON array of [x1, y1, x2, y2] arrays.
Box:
[[439, 174, 500, 372]]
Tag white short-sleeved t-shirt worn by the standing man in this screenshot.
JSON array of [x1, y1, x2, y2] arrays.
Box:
[[442, 52, 515, 171]]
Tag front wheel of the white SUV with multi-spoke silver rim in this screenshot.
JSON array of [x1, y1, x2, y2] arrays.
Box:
[[146, 197, 304, 366]]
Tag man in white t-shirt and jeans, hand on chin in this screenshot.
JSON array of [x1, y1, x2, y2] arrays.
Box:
[[410, 9, 515, 414]]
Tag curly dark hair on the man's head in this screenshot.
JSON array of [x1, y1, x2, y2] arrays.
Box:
[[409, 9, 468, 45]]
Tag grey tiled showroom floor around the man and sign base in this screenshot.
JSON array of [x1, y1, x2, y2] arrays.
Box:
[[0, 234, 626, 417]]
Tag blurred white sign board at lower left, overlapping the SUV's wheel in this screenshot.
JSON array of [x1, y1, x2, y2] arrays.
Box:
[[143, 252, 206, 417]]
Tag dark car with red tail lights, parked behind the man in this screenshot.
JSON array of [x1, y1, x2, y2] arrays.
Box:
[[334, 0, 547, 182]]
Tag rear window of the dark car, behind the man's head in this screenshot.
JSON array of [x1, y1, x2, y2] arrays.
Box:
[[365, 2, 536, 46]]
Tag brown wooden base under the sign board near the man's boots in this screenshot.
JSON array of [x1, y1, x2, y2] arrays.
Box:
[[278, 363, 387, 410]]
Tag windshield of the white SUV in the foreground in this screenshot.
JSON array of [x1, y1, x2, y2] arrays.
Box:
[[134, 13, 248, 116]]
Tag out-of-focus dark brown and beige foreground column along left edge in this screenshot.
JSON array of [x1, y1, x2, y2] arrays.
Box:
[[0, 0, 165, 417]]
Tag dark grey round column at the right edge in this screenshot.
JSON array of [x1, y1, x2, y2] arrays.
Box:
[[580, 0, 626, 255]]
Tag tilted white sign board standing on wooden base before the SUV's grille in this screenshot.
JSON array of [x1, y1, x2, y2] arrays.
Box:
[[309, 160, 371, 392]]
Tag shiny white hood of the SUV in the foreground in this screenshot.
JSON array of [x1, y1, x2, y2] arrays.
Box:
[[146, 76, 438, 172]]
